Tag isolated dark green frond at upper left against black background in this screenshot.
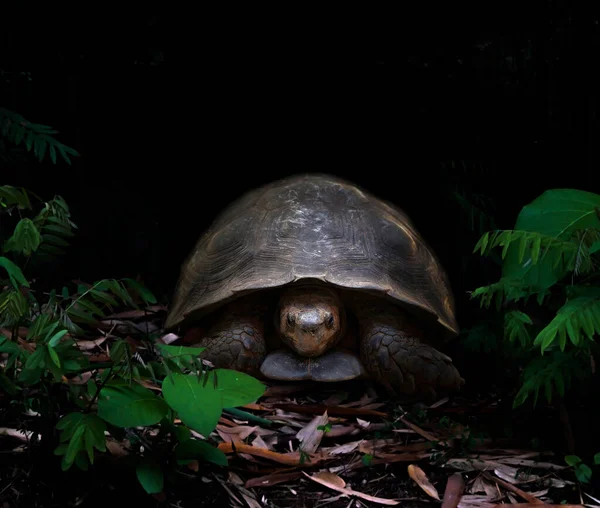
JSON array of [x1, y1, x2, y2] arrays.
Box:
[[0, 108, 79, 164]]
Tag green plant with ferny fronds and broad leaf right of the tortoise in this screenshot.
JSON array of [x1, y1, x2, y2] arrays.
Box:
[[471, 189, 600, 406]]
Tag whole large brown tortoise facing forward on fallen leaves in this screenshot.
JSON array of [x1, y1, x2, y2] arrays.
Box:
[[165, 173, 464, 399]]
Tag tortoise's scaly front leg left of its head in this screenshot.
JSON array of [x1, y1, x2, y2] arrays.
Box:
[[188, 303, 266, 376]]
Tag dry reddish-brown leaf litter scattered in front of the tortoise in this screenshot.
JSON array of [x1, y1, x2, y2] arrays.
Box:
[[0, 309, 600, 508]]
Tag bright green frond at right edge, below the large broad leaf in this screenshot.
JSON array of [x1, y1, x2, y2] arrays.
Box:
[[533, 296, 600, 354]]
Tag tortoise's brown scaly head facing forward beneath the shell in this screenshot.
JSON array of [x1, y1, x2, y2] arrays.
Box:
[[276, 285, 344, 357]]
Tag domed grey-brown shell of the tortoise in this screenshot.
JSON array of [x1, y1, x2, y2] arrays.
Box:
[[165, 174, 459, 338]]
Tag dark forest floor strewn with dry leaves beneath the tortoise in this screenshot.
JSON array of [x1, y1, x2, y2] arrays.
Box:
[[0, 306, 600, 508]]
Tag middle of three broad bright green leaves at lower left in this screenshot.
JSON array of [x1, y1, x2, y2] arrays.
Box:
[[162, 373, 223, 437]]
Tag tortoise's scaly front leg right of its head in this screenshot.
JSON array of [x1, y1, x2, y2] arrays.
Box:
[[357, 302, 464, 401]]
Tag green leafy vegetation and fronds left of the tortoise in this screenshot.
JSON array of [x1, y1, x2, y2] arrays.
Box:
[[0, 110, 264, 493]]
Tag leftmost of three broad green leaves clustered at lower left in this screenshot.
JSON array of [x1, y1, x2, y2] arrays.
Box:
[[98, 380, 169, 427]]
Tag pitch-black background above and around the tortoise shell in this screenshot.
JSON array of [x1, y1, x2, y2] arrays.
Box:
[[0, 2, 600, 330]]
